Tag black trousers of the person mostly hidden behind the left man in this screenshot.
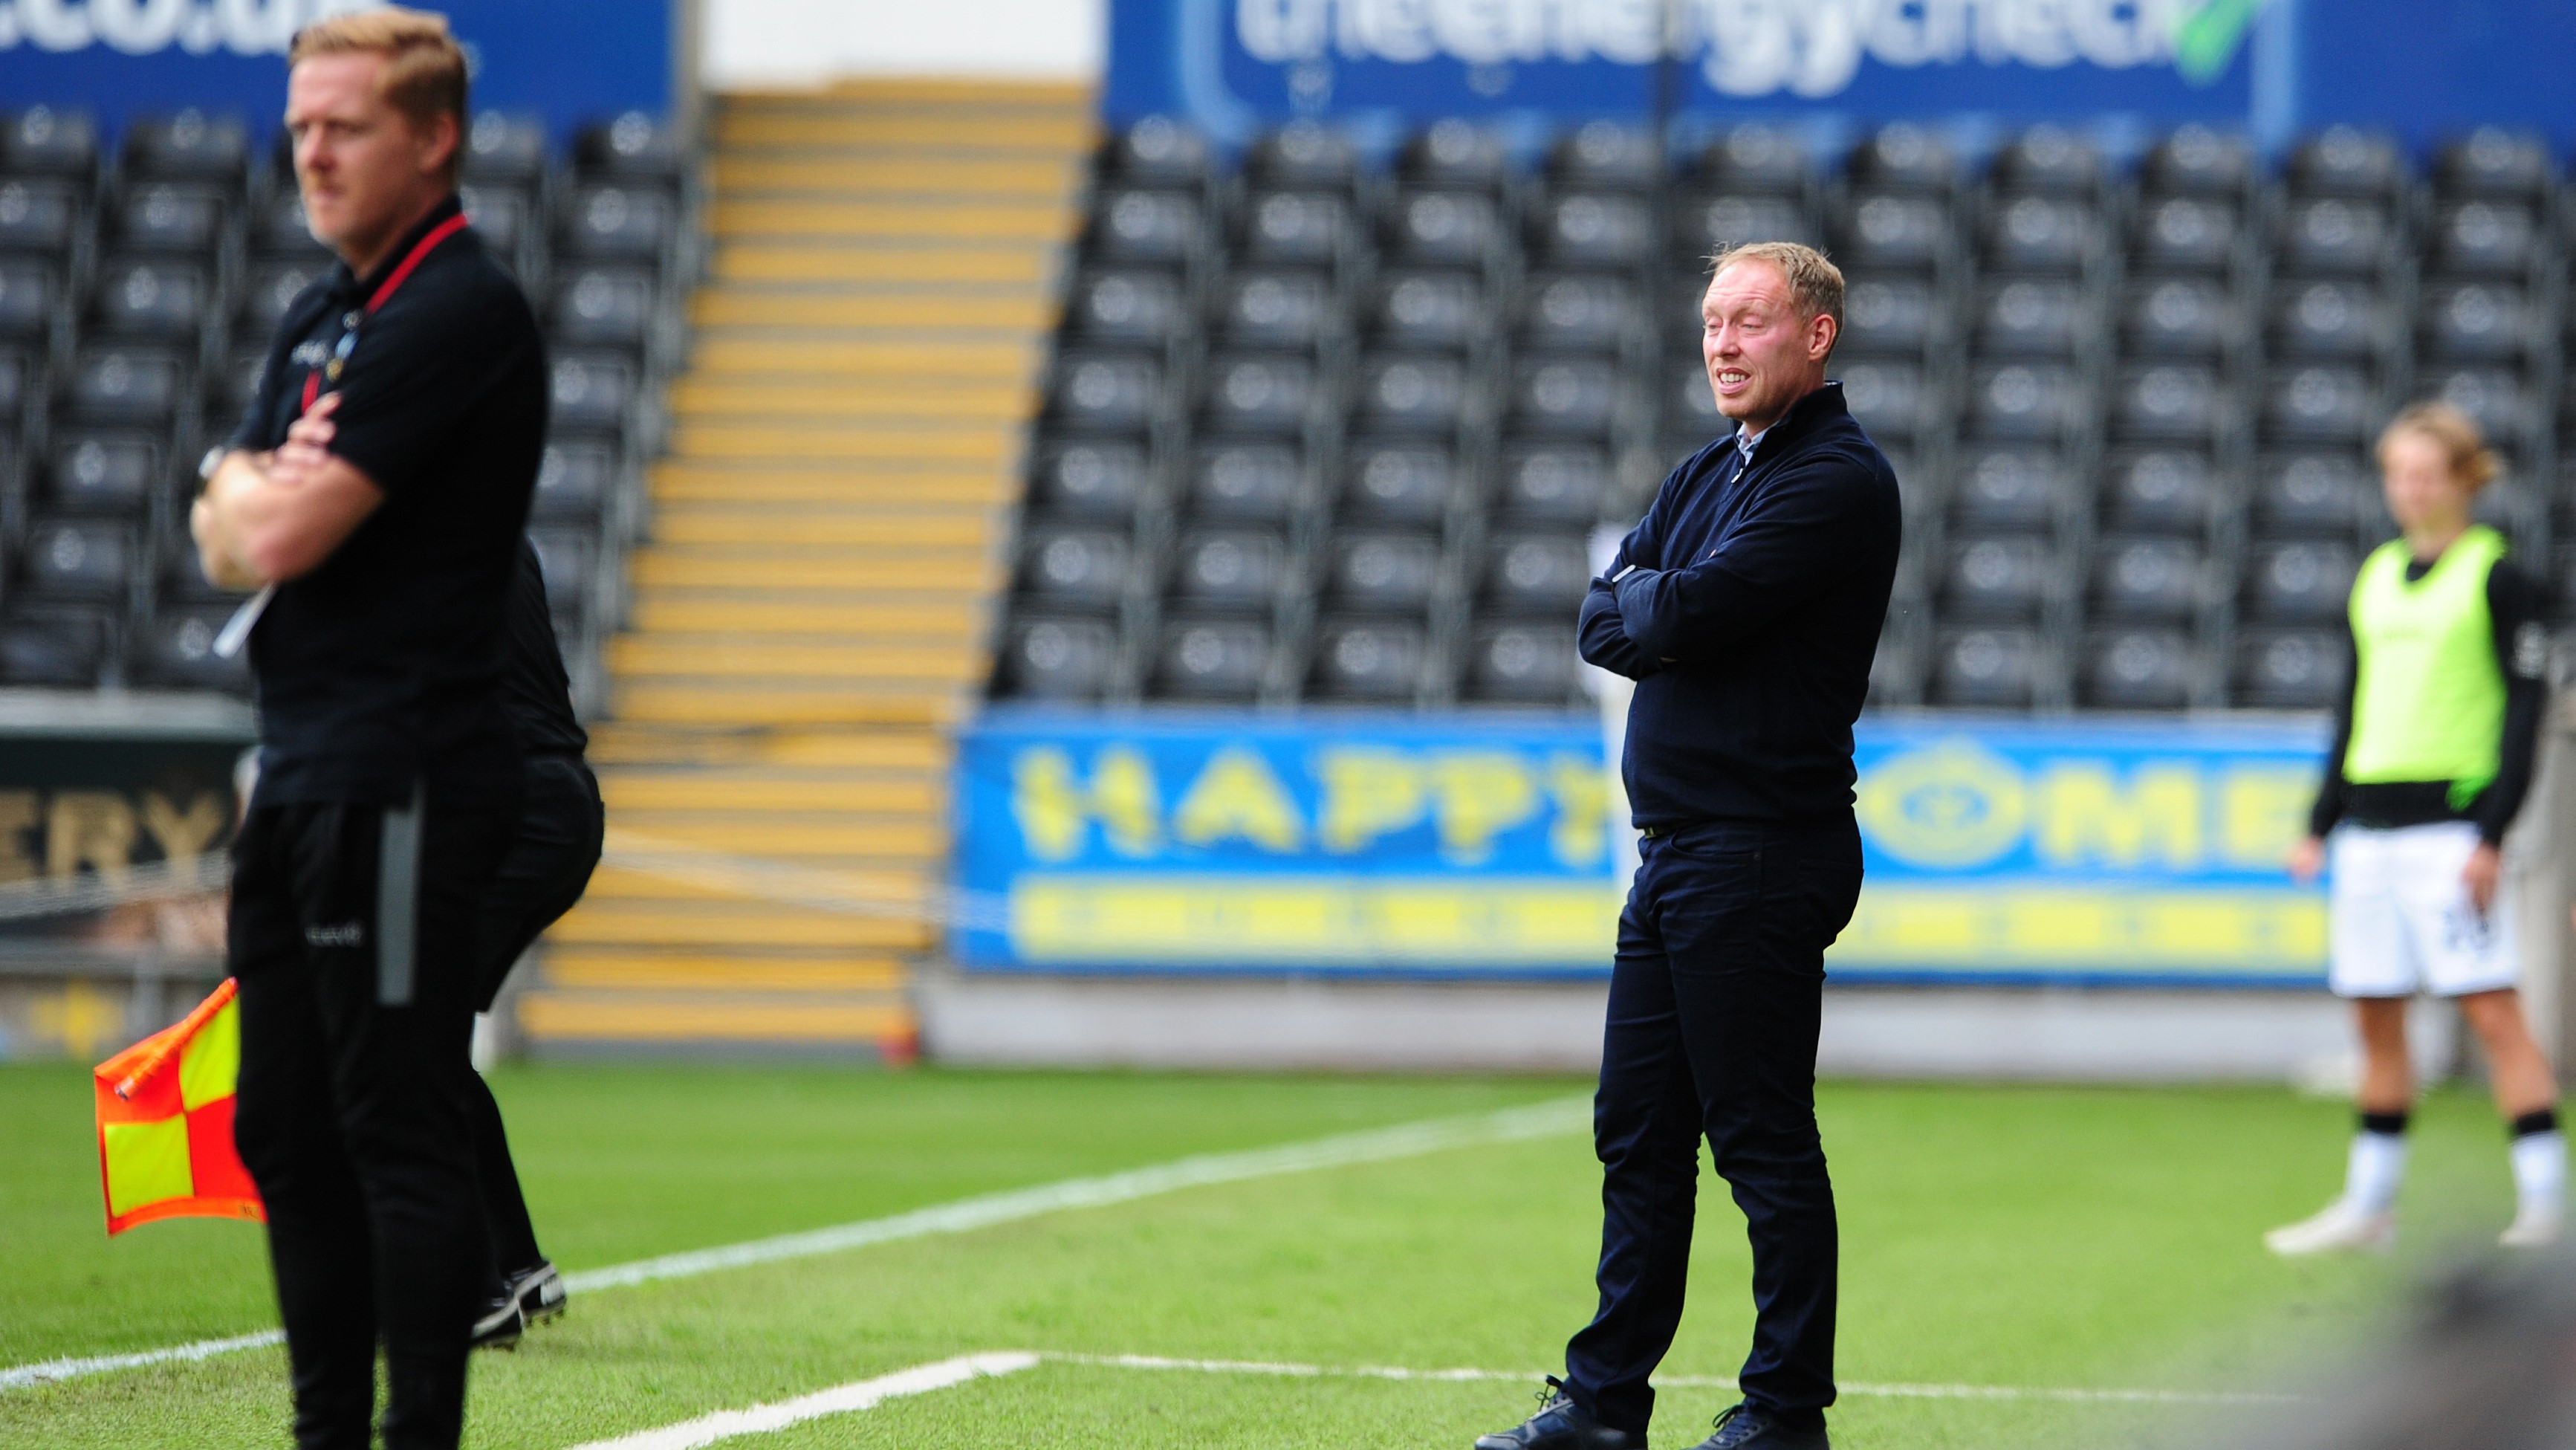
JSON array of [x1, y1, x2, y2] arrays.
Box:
[[467, 754, 603, 1275]]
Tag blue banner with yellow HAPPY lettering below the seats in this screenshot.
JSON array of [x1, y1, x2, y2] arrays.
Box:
[[950, 711, 2326, 984]]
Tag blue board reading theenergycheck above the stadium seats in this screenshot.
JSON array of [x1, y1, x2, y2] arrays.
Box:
[[1103, 0, 2576, 147]]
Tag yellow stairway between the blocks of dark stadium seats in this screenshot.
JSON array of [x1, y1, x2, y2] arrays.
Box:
[[518, 82, 1092, 1058]]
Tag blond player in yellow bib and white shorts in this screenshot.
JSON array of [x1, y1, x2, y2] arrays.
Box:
[[2264, 404, 2566, 1255]]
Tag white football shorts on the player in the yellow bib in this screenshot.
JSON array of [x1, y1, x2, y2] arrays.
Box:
[[2326, 821, 2522, 997]]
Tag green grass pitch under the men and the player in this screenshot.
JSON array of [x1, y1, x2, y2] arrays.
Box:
[[0, 1067, 2511, 1450]]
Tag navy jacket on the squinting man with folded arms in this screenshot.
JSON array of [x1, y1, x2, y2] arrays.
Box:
[[1582, 383, 1901, 826]]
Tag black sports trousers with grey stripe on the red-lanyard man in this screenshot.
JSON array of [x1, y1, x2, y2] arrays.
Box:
[[230, 793, 518, 1450]]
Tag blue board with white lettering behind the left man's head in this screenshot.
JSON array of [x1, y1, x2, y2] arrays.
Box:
[[0, 0, 672, 137]]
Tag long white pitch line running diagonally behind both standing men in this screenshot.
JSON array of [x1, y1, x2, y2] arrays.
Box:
[[0, 1097, 1592, 1394]]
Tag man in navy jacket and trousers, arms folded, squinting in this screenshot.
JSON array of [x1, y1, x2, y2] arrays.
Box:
[[1476, 242, 1898, 1450]]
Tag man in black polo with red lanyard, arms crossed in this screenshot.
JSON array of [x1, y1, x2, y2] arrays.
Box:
[[191, 7, 546, 1450]]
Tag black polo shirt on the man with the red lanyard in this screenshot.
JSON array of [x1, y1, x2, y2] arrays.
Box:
[[232, 195, 548, 803]]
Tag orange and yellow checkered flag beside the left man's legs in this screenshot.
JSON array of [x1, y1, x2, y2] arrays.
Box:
[[95, 976, 265, 1239]]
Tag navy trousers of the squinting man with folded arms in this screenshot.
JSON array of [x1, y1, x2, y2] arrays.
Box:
[[1566, 814, 1860, 1434]]
